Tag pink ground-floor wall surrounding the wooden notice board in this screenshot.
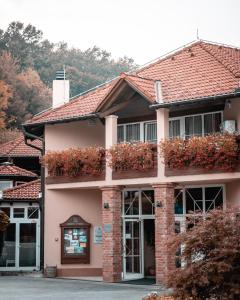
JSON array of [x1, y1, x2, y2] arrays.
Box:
[[44, 190, 102, 268]]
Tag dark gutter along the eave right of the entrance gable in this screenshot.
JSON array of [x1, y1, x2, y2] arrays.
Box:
[[149, 91, 240, 109]]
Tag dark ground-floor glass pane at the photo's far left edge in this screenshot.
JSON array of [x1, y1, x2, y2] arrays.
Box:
[[0, 224, 16, 267]]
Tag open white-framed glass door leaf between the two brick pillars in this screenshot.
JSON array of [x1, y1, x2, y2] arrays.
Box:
[[123, 219, 144, 280]]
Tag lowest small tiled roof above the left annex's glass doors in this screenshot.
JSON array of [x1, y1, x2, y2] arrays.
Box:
[[2, 179, 41, 200]]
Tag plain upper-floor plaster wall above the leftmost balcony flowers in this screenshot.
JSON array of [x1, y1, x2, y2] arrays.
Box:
[[45, 120, 105, 151]]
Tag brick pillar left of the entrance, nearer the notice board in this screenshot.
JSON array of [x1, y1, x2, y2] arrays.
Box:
[[102, 186, 122, 282]]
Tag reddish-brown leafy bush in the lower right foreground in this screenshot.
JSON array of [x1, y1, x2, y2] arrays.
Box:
[[169, 210, 240, 300]]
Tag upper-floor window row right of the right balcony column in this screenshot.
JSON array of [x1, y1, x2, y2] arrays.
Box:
[[169, 112, 222, 138]]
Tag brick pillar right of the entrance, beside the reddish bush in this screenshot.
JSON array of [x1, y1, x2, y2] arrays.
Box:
[[153, 184, 175, 285]]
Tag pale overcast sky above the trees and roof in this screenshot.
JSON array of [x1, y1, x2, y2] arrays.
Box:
[[0, 0, 240, 64]]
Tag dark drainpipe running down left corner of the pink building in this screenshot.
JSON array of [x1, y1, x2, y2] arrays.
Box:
[[22, 126, 45, 271]]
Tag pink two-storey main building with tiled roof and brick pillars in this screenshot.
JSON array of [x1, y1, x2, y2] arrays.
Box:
[[24, 41, 240, 283]]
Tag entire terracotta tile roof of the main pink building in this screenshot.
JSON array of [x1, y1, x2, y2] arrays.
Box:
[[24, 41, 240, 124]]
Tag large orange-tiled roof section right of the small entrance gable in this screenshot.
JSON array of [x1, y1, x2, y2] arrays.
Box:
[[136, 41, 240, 102]]
